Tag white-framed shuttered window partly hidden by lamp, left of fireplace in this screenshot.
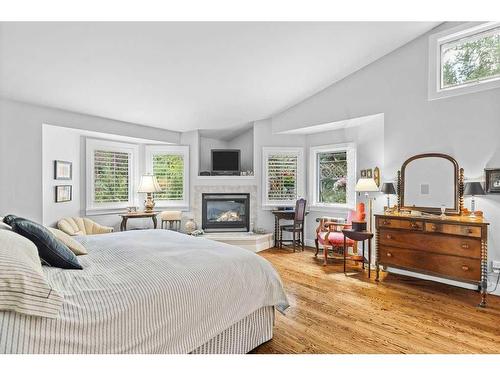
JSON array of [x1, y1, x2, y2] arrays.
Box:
[[146, 145, 189, 208]]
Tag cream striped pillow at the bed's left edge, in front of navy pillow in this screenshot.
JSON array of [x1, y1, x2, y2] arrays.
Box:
[[0, 230, 63, 318]]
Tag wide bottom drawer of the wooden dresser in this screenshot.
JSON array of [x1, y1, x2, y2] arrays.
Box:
[[379, 246, 481, 282]]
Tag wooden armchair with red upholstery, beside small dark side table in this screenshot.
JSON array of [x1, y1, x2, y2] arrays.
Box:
[[314, 203, 366, 266]]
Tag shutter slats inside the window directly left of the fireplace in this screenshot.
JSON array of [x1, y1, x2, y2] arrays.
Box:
[[153, 154, 184, 200]]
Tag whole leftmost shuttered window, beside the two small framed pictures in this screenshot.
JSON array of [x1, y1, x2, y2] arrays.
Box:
[[86, 138, 138, 211]]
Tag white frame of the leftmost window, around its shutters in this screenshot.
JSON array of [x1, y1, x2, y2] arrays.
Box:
[[85, 137, 139, 215]]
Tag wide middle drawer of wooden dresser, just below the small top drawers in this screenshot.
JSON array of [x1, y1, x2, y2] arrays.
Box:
[[379, 229, 481, 259]]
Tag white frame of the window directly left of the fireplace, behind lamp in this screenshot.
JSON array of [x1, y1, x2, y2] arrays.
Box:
[[144, 145, 190, 211]]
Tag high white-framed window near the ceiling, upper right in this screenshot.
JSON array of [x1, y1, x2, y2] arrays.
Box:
[[429, 22, 500, 99]]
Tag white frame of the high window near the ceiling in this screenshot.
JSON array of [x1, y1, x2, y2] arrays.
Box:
[[428, 22, 500, 100]]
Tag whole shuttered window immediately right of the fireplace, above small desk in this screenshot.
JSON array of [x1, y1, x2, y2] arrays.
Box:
[[262, 147, 304, 206]]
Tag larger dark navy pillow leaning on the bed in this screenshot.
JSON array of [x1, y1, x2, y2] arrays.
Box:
[[12, 218, 82, 270]]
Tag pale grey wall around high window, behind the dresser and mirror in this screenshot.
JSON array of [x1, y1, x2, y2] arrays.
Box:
[[272, 24, 500, 276]]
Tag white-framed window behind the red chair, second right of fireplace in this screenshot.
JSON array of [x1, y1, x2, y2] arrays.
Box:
[[309, 143, 356, 208]]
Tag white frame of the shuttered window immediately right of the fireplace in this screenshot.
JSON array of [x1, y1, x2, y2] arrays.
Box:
[[261, 146, 305, 208]]
